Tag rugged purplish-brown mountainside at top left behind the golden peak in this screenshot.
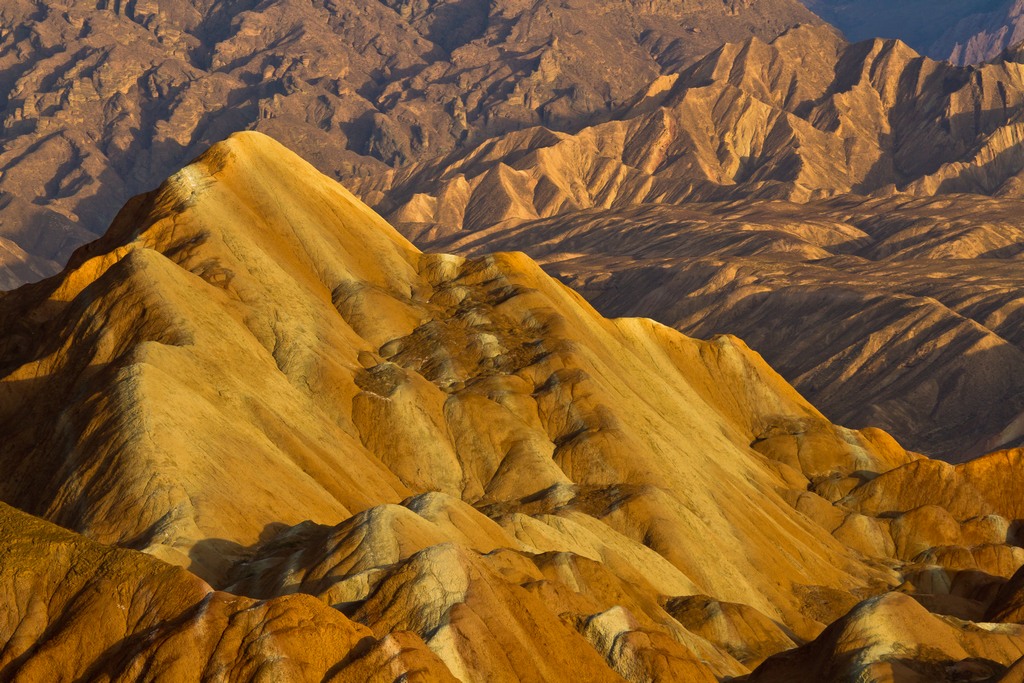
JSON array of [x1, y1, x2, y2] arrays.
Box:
[[0, 0, 818, 285]]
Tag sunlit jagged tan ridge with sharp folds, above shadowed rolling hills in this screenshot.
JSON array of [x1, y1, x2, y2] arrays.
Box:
[[353, 26, 1024, 238]]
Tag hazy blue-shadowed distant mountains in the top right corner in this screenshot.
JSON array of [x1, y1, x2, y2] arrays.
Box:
[[806, 0, 1024, 63]]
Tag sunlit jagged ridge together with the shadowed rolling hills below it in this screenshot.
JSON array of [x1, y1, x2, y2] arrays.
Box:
[[352, 27, 1024, 460]]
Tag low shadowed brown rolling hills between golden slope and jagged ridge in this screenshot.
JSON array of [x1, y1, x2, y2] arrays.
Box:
[[425, 196, 1024, 460]]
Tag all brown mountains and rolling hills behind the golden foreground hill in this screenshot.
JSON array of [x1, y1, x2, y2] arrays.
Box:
[[0, 6, 1024, 461]]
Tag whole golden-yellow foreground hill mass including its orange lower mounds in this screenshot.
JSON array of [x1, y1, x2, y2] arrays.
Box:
[[6, 133, 1024, 681]]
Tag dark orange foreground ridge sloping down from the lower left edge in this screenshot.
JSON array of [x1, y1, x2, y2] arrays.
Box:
[[0, 504, 454, 681]]
